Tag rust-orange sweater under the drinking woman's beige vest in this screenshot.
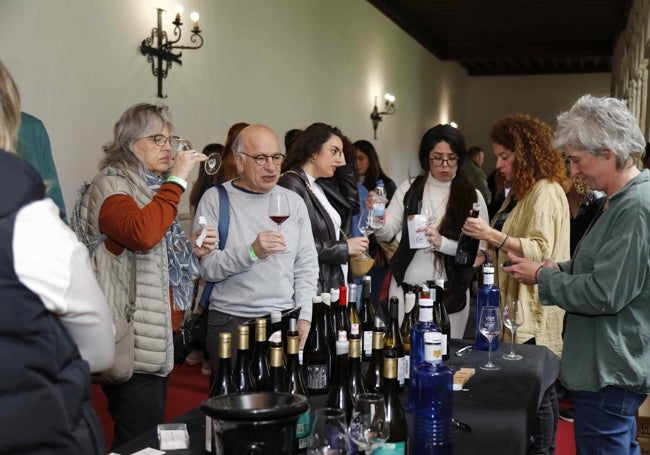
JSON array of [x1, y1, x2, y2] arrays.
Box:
[[99, 183, 183, 331]]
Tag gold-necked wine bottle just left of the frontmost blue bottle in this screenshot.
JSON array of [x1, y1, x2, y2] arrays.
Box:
[[375, 348, 408, 455]]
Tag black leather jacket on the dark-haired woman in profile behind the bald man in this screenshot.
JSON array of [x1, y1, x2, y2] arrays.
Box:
[[278, 164, 359, 292]]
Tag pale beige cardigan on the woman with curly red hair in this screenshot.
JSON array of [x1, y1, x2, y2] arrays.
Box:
[[492, 179, 570, 355]]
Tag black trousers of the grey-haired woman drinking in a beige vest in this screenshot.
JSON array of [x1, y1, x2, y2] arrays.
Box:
[[102, 373, 169, 448]]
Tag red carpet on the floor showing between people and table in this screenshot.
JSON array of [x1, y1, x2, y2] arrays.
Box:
[[93, 364, 576, 455]]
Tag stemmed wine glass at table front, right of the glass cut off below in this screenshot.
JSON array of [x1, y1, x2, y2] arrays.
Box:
[[349, 393, 390, 455]]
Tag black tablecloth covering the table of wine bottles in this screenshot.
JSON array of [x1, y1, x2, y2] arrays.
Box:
[[115, 340, 560, 455]]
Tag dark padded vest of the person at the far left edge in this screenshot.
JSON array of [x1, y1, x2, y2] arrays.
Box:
[[0, 151, 106, 455]]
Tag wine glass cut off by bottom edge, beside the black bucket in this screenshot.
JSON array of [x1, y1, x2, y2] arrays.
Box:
[[307, 408, 351, 455]]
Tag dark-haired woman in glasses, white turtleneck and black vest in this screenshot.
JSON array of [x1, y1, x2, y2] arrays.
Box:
[[375, 125, 488, 338]]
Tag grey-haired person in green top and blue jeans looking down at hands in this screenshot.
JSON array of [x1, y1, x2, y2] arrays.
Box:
[[504, 95, 650, 455]]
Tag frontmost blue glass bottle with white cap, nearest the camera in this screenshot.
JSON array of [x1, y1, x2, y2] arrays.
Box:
[[412, 332, 454, 455]]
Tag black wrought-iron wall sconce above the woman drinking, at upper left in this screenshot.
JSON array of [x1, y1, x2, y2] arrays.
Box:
[[140, 5, 203, 98]]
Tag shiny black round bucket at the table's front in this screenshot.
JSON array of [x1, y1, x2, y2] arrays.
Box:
[[201, 392, 309, 455]]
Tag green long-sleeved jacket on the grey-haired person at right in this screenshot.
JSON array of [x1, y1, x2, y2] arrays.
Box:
[[538, 170, 650, 394]]
